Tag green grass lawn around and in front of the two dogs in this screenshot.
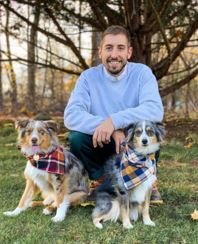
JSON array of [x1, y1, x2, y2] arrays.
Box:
[[0, 125, 198, 244]]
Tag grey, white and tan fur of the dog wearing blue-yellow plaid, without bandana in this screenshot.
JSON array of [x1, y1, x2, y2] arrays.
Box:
[[92, 121, 165, 229]]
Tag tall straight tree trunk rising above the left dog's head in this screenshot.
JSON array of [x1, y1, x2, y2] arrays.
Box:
[[27, 4, 40, 111]]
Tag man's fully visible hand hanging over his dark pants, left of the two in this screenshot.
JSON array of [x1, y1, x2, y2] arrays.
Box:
[[92, 117, 115, 147]]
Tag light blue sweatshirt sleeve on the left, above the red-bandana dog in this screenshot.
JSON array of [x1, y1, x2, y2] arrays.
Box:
[[64, 73, 104, 135]]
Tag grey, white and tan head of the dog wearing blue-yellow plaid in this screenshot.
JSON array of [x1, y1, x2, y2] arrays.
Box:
[[125, 121, 165, 155]]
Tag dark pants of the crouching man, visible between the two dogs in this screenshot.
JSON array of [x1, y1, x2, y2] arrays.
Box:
[[69, 131, 116, 180]]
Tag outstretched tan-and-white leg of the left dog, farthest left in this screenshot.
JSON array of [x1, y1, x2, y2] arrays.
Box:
[[4, 179, 35, 216]]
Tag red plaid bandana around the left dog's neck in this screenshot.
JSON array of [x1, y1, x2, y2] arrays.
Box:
[[27, 147, 65, 174]]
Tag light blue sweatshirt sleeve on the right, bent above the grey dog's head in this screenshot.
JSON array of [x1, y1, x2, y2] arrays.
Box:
[[111, 66, 164, 129]]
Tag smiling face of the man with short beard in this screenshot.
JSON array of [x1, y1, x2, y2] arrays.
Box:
[[99, 34, 132, 76]]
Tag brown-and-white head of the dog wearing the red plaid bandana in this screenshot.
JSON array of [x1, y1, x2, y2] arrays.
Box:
[[15, 120, 59, 156]]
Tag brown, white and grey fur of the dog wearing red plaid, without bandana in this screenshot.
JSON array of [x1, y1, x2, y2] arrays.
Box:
[[4, 120, 89, 222]]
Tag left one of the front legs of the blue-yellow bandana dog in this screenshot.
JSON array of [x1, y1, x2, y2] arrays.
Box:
[[120, 192, 133, 229]]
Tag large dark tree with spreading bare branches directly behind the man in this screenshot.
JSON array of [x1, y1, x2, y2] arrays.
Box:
[[0, 0, 198, 103]]
